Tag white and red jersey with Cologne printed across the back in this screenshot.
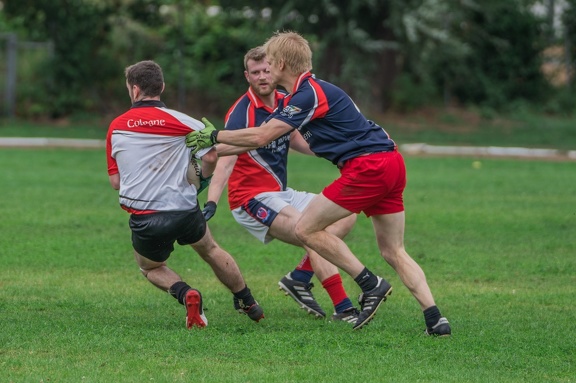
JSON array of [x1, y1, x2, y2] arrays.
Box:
[[106, 101, 211, 214]]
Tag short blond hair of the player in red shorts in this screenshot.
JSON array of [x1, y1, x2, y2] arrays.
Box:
[[264, 31, 312, 75]]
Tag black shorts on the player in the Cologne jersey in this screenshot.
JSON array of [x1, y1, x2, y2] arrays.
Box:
[[129, 207, 206, 262]]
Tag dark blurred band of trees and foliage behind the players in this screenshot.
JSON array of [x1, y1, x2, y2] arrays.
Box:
[[0, 0, 576, 121]]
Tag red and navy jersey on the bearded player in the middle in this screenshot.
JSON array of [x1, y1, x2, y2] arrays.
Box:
[[225, 88, 290, 210]]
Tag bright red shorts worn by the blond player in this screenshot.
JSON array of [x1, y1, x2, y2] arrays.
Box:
[[322, 150, 406, 217]]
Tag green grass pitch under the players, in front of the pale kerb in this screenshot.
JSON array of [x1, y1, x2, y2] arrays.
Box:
[[0, 149, 576, 382]]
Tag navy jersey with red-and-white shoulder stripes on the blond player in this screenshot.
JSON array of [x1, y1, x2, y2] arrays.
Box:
[[270, 72, 396, 165]]
